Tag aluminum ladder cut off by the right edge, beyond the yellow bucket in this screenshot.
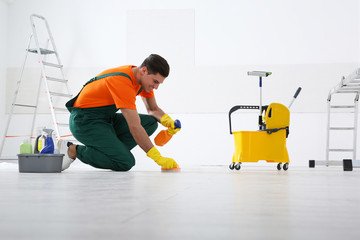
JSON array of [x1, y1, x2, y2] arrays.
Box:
[[309, 68, 360, 171]]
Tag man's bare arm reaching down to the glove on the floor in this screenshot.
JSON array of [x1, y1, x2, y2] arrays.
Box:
[[120, 108, 154, 153]]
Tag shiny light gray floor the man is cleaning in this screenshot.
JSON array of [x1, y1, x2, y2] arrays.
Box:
[[0, 163, 360, 240]]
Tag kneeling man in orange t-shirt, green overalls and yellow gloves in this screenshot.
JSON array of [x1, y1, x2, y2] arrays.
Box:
[[58, 54, 180, 171]]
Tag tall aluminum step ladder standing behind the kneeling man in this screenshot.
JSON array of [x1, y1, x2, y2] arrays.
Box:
[[0, 14, 72, 159]]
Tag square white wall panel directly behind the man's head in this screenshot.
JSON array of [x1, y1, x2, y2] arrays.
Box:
[[126, 9, 195, 75]]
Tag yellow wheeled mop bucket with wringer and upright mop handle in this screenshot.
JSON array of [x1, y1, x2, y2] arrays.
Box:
[[229, 71, 301, 171]]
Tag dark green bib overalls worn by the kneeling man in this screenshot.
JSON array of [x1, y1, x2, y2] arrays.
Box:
[[66, 72, 158, 171]]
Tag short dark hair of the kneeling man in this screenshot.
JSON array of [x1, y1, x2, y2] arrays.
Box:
[[140, 54, 170, 78]]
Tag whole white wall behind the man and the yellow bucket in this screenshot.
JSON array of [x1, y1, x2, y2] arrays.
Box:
[[3, 0, 360, 167]]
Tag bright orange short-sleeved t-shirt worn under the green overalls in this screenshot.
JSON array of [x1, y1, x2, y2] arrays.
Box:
[[74, 65, 154, 110]]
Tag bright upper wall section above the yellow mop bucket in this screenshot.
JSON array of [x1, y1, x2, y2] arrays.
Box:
[[196, 0, 359, 65]]
